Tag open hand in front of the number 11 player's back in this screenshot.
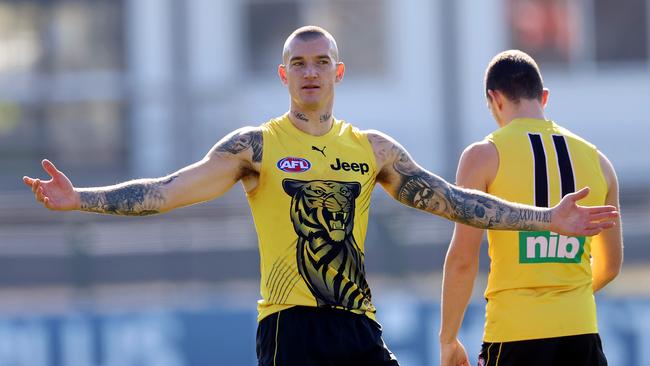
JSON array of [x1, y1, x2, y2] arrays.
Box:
[[551, 187, 619, 236]]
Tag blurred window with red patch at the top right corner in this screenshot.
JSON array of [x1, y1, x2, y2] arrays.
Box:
[[505, 0, 649, 65]]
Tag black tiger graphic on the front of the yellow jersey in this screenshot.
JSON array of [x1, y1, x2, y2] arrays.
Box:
[[282, 179, 374, 311]]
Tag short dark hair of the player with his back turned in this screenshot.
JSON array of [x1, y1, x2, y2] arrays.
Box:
[[485, 50, 544, 102]]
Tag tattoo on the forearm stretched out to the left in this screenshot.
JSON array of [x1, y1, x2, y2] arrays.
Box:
[[79, 175, 178, 216]]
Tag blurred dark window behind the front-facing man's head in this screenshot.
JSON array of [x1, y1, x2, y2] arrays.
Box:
[[244, 0, 387, 77]]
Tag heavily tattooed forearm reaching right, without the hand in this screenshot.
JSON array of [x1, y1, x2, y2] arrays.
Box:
[[393, 148, 551, 230]]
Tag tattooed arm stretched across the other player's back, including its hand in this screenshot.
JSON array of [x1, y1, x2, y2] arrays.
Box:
[[368, 131, 618, 235]]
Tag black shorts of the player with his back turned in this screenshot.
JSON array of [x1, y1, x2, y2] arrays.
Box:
[[478, 334, 607, 366]]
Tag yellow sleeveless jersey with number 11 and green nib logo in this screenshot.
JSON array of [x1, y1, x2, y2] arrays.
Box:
[[484, 119, 608, 342]]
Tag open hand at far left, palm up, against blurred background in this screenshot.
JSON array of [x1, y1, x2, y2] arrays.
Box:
[[23, 159, 80, 211]]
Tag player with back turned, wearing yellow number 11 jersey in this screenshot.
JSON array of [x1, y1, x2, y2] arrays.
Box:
[[440, 50, 623, 366]]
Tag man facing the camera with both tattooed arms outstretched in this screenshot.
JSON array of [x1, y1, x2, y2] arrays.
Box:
[[24, 26, 617, 366]]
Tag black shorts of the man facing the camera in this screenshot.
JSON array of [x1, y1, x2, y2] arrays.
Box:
[[257, 306, 399, 366]]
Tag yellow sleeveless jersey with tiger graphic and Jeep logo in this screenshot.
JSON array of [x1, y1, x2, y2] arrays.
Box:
[[248, 114, 377, 321]]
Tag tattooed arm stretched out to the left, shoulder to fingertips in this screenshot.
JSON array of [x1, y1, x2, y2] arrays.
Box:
[[23, 127, 262, 216]]
